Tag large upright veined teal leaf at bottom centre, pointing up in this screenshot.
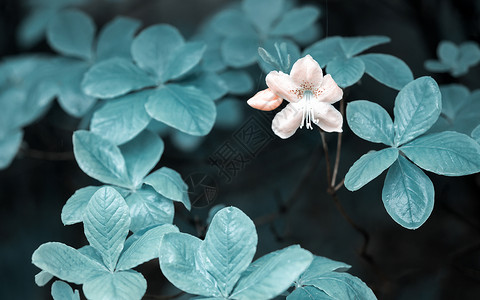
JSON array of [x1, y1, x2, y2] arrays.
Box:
[[199, 207, 257, 297]]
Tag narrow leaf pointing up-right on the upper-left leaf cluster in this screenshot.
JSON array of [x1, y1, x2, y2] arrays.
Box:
[[163, 42, 206, 81]]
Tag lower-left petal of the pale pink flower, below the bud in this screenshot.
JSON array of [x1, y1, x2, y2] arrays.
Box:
[[272, 103, 303, 139]]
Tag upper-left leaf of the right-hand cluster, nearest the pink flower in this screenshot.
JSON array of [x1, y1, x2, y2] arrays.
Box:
[[347, 100, 395, 146]]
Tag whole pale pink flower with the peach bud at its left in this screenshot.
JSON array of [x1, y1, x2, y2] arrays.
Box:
[[248, 55, 343, 139]]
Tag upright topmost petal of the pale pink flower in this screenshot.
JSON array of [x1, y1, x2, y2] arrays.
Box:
[[290, 55, 323, 89]]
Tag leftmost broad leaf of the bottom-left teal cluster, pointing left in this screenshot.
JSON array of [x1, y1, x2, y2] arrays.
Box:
[[32, 242, 106, 284]]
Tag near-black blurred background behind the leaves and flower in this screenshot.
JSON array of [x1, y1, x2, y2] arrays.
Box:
[[0, 0, 480, 299]]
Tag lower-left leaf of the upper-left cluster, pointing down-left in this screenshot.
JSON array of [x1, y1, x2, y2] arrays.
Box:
[[90, 90, 152, 145]]
